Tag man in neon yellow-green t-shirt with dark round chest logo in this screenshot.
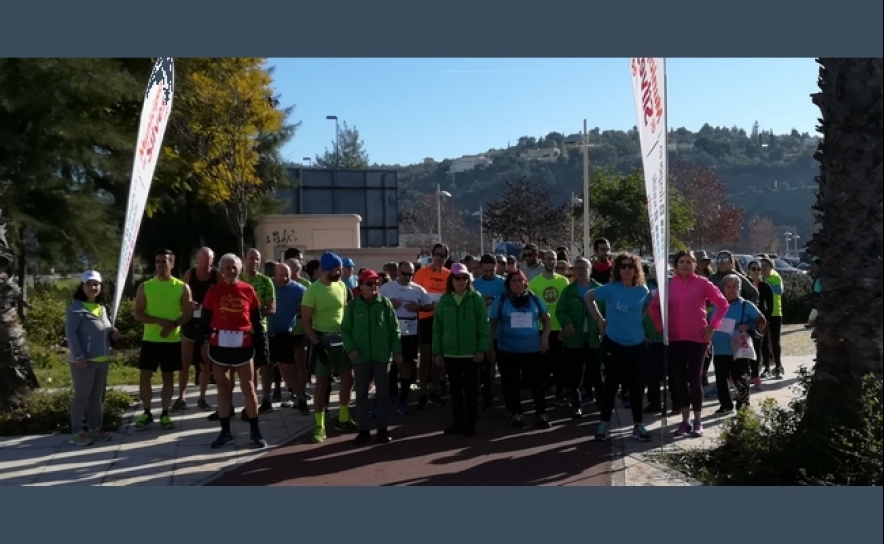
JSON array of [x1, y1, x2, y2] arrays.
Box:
[[528, 250, 570, 406]]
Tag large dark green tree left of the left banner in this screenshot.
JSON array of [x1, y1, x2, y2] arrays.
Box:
[[0, 59, 141, 297]]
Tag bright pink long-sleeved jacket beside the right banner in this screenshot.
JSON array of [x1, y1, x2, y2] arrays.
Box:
[[649, 274, 728, 344]]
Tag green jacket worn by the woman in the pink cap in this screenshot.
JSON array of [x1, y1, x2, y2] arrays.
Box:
[[433, 291, 491, 357]]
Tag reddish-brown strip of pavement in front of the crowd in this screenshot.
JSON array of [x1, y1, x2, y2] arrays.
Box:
[[209, 388, 611, 486]]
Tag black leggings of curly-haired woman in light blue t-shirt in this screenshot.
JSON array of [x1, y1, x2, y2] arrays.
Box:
[[601, 339, 648, 425]]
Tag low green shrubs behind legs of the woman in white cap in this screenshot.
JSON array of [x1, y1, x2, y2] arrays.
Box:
[[0, 388, 134, 436]]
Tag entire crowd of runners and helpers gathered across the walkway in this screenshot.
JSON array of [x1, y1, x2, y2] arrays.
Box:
[[65, 238, 783, 448]]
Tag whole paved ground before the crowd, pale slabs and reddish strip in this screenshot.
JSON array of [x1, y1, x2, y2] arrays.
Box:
[[0, 355, 813, 486]]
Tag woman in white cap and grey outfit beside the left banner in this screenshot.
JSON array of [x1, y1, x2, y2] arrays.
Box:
[[64, 270, 119, 446]]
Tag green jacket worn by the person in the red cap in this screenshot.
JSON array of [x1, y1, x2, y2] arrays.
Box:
[[341, 295, 402, 364]]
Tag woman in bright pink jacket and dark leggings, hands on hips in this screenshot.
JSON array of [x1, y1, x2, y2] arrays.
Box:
[[650, 251, 728, 436]]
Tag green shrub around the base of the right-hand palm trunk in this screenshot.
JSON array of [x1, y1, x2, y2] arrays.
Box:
[[658, 369, 884, 486]]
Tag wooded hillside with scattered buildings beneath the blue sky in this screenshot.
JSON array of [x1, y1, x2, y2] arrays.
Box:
[[383, 123, 819, 240]]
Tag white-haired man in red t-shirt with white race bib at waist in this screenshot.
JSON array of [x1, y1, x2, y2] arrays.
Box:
[[200, 253, 269, 448]]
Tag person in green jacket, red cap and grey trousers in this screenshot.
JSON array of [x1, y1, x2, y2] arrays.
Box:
[[341, 270, 402, 445]]
